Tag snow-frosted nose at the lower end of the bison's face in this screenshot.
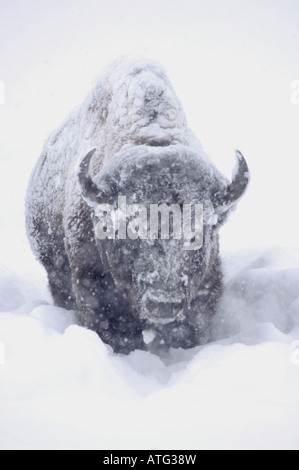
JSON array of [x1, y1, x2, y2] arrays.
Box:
[[145, 299, 184, 323]]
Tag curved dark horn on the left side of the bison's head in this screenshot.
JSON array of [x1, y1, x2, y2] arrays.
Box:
[[77, 148, 101, 207]]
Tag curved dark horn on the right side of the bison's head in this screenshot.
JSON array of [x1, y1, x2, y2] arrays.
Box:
[[212, 150, 250, 216]]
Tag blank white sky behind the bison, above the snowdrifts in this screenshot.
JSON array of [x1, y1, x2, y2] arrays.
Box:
[[0, 0, 299, 258]]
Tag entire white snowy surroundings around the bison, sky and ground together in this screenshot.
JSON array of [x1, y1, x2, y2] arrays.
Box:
[[0, 0, 299, 450]]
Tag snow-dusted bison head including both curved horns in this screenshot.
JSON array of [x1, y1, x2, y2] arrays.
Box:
[[78, 145, 248, 325]]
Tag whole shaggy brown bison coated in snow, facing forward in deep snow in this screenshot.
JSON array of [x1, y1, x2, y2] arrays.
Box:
[[26, 57, 248, 353]]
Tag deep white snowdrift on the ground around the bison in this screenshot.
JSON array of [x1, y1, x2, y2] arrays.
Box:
[[0, 244, 299, 449]]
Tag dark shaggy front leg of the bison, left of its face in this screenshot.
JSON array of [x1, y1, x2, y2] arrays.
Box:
[[67, 242, 145, 354]]
